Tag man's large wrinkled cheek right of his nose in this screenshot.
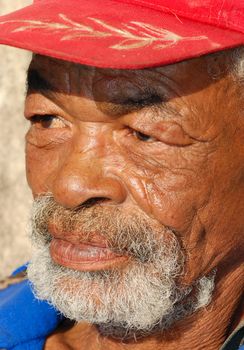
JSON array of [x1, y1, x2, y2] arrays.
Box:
[[122, 148, 211, 232]]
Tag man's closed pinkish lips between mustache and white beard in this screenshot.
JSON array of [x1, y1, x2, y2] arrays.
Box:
[[50, 237, 129, 271]]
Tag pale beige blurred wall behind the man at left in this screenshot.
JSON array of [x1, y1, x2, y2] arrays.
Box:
[[0, 0, 31, 278]]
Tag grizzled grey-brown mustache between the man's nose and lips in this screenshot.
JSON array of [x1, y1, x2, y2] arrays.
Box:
[[31, 195, 179, 262]]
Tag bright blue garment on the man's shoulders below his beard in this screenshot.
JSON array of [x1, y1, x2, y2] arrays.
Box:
[[0, 266, 244, 350]]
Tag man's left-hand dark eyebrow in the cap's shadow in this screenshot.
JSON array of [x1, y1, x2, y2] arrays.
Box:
[[26, 69, 57, 95]]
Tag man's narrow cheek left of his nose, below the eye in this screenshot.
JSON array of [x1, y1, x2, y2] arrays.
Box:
[[26, 145, 59, 196]]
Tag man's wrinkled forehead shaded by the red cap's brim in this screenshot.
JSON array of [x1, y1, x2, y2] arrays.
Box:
[[28, 52, 233, 99]]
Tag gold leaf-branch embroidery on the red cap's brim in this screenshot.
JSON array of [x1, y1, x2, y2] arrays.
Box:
[[0, 14, 208, 50]]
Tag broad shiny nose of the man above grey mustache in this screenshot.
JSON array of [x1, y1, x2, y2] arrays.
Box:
[[50, 154, 126, 208]]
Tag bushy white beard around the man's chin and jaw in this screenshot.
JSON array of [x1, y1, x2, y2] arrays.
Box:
[[28, 196, 214, 337]]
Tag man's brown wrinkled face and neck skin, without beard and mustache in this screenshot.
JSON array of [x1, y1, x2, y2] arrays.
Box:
[[25, 53, 244, 350]]
